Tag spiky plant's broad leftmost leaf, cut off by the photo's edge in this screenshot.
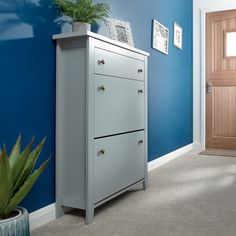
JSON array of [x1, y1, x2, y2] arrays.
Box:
[[0, 148, 13, 218]]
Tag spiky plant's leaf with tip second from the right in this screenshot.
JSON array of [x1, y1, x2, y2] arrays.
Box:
[[14, 138, 46, 193]]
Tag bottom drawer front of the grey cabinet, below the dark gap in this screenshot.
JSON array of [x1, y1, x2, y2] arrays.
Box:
[[94, 131, 145, 203]]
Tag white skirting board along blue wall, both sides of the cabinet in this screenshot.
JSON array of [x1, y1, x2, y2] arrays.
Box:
[[29, 144, 193, 230]]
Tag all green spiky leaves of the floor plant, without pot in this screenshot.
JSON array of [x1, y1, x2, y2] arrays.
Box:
[[0, 135, 49, 219]]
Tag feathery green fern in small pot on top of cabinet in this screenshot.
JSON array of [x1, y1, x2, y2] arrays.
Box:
[[54, 0, 110, 33]]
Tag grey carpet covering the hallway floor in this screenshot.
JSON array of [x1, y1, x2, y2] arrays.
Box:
[[31, 152, 236, 236]]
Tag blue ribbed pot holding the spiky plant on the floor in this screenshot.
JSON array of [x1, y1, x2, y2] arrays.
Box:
[[0, 207, 30, 236]]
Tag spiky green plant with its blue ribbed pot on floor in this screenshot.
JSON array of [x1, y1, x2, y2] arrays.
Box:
[[0, 136, 49, 236]]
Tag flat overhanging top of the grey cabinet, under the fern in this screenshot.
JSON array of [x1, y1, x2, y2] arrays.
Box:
[[53, 31, 150, 56]]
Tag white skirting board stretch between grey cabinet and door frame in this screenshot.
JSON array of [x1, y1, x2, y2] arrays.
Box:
[[148, 143, 194, 171]]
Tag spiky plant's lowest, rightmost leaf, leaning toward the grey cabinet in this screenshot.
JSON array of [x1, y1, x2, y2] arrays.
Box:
[[4, 159, 50, 215]]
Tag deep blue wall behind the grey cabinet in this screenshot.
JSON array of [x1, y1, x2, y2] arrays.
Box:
[[0, 0, 192, 212]]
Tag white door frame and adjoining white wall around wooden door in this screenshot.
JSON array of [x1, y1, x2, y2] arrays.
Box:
[[193, 0, 236, 146]]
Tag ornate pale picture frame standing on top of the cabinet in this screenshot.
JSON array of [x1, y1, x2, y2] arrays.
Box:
[[107, 18, 134, 46]]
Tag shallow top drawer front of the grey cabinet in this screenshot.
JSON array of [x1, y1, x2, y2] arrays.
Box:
[[94, 48, 144, 80]]
